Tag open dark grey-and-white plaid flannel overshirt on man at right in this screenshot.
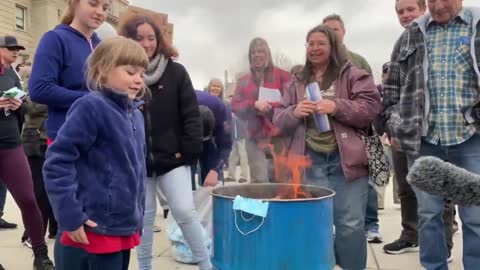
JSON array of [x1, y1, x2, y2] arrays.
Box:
[[381, 8, 480, 154]]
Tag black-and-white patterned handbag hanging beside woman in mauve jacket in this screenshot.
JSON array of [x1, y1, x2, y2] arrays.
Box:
[[357, 127, 390, 187]]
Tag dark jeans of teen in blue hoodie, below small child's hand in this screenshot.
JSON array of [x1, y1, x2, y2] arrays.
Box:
[[53, 230, 89, 270]]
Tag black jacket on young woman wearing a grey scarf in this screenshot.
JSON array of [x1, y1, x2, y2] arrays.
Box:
[[143, 61, 202, 176]]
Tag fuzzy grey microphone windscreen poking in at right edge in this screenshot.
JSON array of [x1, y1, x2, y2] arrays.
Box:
[[407, 157, 480, 206]]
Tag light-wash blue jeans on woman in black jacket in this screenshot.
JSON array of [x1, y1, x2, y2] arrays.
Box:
[[137, 166, 212, 270]]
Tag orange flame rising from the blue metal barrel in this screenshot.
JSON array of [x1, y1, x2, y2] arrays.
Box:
[[259, 144, 312, 199]]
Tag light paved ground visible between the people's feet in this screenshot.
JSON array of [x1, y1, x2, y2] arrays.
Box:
[[0, 181, 463, 270]]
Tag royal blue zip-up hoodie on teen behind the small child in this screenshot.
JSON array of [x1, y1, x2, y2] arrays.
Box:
[[29, 24, 100, 139]]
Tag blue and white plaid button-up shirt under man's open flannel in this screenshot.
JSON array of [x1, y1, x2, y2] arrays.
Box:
[[425, 10, 480, 146]]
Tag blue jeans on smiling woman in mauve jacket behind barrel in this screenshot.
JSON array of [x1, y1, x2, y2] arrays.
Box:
[[306, 149, 368, 270]]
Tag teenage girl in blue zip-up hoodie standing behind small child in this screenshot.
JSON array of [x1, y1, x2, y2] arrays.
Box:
[[29, 0, 111, 270]]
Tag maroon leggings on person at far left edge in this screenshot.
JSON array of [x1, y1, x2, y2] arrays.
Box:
[[0, 145, 45, 247]]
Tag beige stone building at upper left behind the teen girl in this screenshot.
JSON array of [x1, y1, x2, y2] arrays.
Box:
[[0, 0, 129, 62]]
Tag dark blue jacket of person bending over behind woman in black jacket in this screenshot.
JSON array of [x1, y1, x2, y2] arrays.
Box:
[[195, 90, 232, 172]]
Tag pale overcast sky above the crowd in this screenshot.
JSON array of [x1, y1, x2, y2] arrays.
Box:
[[130, 0, 480, 89]]
